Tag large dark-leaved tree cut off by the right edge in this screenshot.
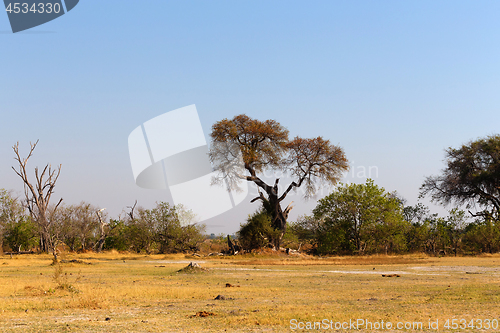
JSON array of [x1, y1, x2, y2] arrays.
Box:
[[420, 135, 500, 222]]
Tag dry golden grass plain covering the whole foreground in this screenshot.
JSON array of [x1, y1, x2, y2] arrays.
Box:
[[0, 252, 500, 332]]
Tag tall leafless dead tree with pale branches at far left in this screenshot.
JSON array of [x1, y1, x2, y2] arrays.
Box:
[[12, 140, 63, 261]]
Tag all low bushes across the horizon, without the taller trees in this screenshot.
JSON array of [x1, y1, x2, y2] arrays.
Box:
[[0, 179, 500, 255]]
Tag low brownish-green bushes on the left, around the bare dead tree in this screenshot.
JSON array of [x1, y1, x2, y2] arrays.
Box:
[[0, 189, 206, 254]]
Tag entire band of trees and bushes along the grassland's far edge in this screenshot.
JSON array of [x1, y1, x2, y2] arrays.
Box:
[[0, 115, 500, 255]]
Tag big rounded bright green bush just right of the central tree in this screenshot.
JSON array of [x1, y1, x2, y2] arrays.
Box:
[[313, 179, 409, 254]]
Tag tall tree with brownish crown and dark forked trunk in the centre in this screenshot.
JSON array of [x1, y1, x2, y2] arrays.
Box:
[[209, 114, 349, 248]]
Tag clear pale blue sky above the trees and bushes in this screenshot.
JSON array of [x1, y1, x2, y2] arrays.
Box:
[[0, 0, 500, 233]]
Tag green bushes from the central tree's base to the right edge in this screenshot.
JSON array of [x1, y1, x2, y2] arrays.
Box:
[[245, 179, 500, 255]]
